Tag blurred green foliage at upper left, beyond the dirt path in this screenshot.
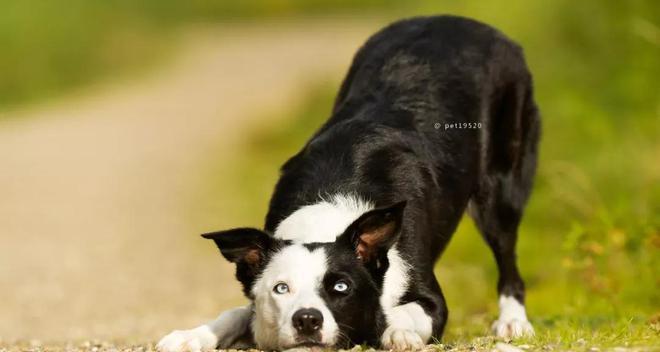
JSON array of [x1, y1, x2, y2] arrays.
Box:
[[0, 0, 404, 108]]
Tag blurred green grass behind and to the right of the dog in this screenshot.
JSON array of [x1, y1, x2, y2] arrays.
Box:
[[200, 1, 660, 342]]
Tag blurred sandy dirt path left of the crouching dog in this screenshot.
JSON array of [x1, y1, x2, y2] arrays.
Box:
[[0, 19, 378, 341]]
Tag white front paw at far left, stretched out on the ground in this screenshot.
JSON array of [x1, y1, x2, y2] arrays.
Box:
[[156, 326, 218, 352]]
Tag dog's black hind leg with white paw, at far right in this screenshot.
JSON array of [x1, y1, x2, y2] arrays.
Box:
[[468, 71, 540, 338]]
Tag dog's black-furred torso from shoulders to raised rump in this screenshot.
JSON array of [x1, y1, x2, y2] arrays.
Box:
[[266, 16, 540, 249]]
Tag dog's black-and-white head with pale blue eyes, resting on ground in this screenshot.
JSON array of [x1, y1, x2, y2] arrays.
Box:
[[203, 202, 405, 350]]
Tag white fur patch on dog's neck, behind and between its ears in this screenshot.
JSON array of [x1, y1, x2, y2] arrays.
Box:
[[275, 194, 374, 243]]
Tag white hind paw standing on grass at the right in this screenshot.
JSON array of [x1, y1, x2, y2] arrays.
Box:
[[492, 295, 534, 338]]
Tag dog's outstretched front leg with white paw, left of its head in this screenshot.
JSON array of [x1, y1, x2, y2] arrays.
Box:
[[156, 305, 252, 352]]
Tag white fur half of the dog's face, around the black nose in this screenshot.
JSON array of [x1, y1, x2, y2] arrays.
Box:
[[252, 244, 338, 350]]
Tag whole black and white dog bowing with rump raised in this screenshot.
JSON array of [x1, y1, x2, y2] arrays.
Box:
[[158, 16, 540, 351]]
